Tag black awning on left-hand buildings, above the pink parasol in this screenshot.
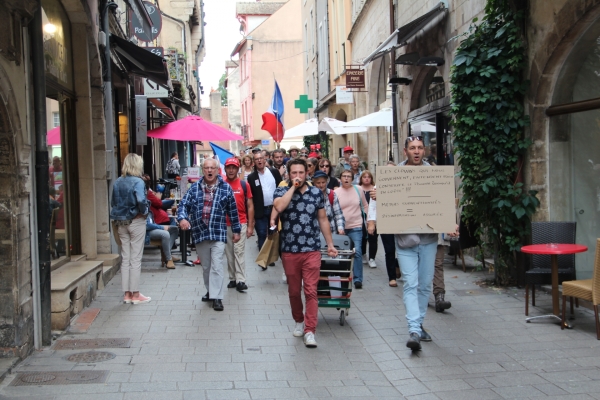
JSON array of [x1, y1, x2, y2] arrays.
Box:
[[110, 35, 173, 91]]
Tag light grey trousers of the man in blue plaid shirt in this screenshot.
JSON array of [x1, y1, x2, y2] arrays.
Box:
[[196, 240, 225, 300]]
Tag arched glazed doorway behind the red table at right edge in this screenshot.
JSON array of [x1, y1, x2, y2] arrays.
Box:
[[548, 19, 600, 279]]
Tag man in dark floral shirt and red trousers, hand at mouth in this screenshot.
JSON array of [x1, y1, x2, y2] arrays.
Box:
[[273, 158, 338, 347]]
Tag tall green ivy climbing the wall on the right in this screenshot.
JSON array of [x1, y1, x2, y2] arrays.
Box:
[[450, 0, 539, 284]]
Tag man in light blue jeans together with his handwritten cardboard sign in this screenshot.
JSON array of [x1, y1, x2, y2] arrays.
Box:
[[368, 136, 457, 351]]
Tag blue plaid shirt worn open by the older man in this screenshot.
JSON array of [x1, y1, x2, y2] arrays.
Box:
[[177, 176, 242, 243]]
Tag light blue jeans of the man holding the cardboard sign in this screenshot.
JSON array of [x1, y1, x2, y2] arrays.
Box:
[[396, 242, 437, 334]]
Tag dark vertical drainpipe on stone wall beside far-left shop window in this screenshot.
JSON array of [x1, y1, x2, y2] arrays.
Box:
[[26, 6, 52, 346]]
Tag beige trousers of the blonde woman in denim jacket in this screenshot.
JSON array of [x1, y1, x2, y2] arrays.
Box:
[[119, 218, 146, 292]]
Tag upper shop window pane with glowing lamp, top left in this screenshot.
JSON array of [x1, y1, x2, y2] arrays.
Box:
[[42, 0, 73, 90]]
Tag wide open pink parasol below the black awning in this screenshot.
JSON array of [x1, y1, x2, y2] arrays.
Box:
[[148, 115, 244, 142]]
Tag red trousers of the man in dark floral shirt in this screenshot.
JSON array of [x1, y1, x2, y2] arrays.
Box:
[[281, 251, 321, 333]]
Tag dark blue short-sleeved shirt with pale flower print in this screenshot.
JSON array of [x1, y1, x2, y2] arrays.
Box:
[[273, 186, 325, 253]]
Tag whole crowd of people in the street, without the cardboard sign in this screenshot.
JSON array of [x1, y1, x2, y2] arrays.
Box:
[[110, 136, 457, 350]]
